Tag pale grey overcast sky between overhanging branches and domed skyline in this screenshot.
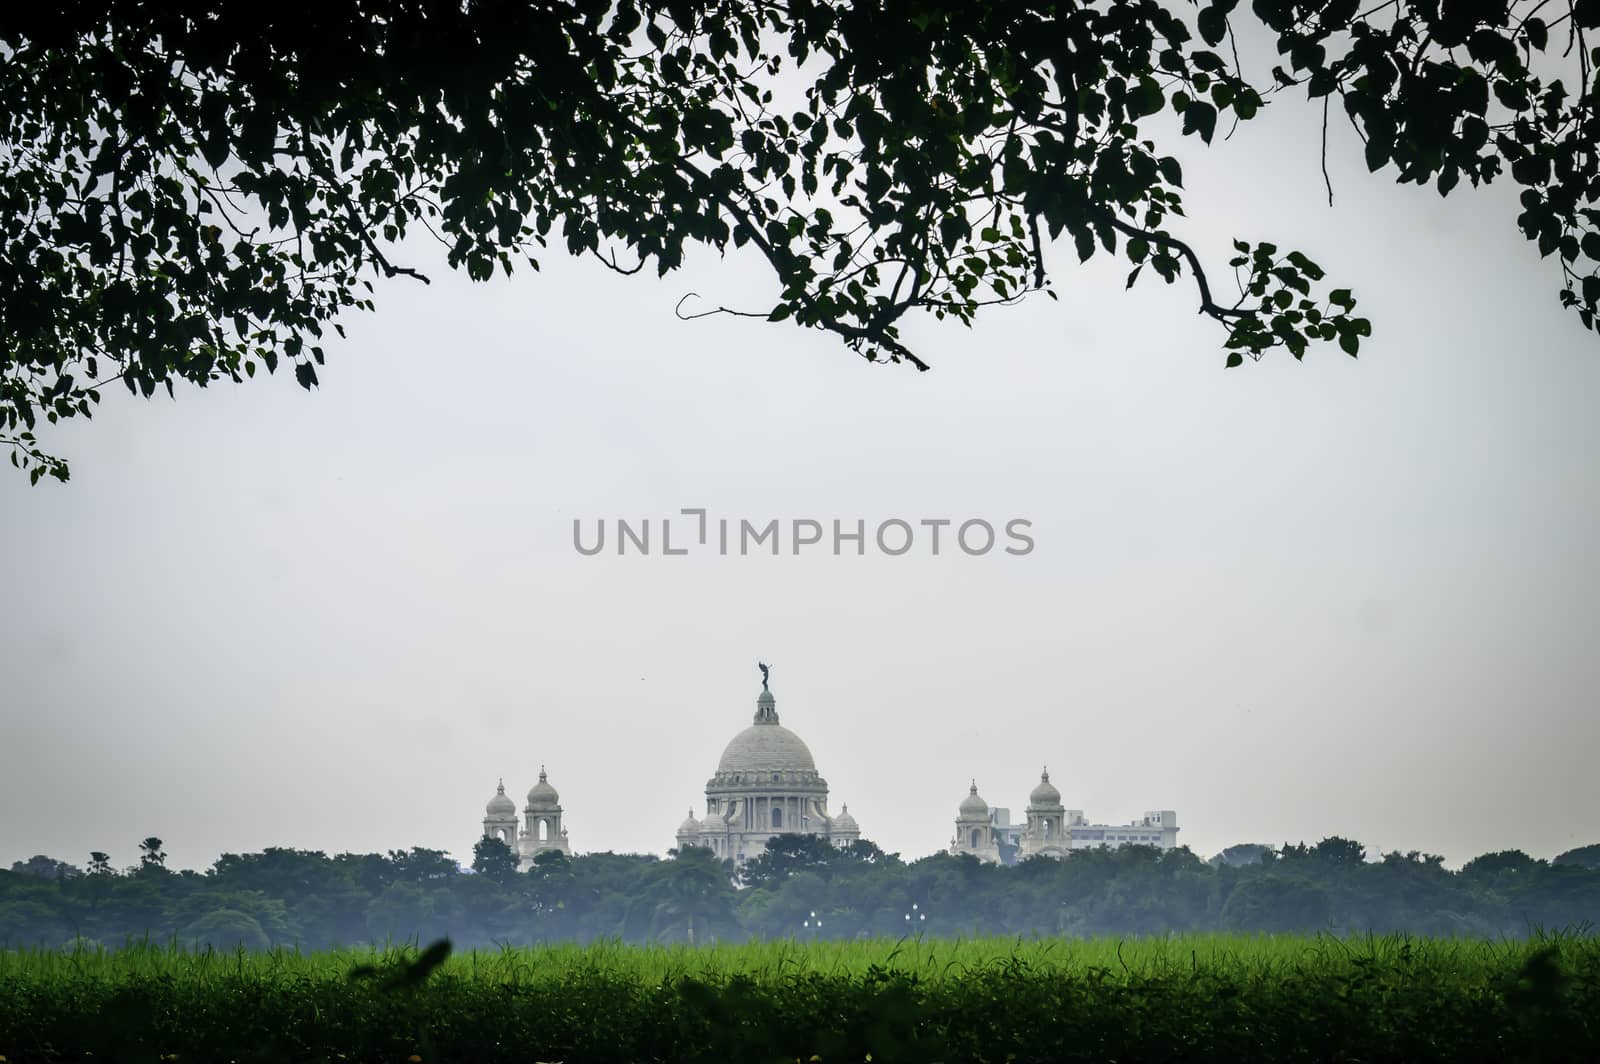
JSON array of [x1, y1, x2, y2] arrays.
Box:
[[0, 60, 1600, 867]]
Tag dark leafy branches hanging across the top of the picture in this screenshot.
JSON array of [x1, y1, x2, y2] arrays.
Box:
[[0, 0, 1600, 480]]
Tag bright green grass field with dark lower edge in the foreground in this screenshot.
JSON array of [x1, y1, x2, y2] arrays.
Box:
[[0, 936, 1600, 1064]]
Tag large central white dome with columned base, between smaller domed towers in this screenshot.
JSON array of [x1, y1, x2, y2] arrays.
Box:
[[677, 683, 861, 862]]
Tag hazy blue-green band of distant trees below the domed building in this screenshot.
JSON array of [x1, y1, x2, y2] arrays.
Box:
[[0, 835, 1600, 949]]
